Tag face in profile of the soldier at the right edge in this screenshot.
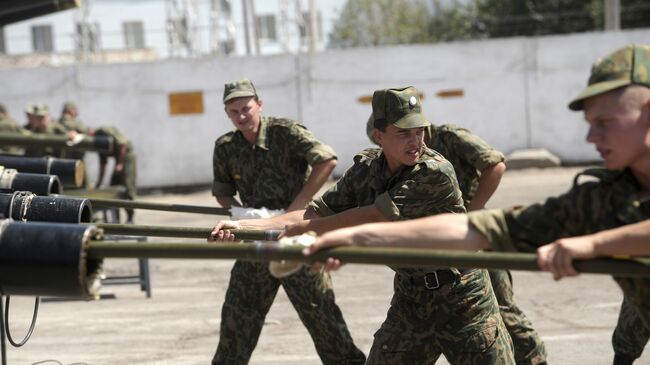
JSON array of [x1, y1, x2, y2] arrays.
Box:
[[584, 88, 650, 170]]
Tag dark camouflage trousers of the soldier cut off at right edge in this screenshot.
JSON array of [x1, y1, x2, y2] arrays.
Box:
[[612, 277, 650, 363]]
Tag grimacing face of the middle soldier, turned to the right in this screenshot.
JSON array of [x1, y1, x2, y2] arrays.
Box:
[[375, 124, 424, 173]]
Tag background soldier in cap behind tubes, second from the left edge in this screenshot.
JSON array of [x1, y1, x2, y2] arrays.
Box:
[[24, 104, 73, 158]]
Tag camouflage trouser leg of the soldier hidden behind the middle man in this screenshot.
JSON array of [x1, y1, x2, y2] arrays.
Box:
[[488, 270, 546, 365]]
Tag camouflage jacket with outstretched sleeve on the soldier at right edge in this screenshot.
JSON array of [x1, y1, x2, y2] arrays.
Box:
[[469, 169, 650, 252]]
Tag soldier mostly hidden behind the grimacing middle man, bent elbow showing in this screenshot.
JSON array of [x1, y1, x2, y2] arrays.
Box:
[[366, 115, 546, 365]]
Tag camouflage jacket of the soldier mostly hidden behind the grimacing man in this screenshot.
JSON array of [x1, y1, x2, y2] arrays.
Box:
[[427, 124, 505, 206]]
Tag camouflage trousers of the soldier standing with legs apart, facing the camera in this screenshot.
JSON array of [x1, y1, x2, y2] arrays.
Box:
[[212, 261, 366, 365]]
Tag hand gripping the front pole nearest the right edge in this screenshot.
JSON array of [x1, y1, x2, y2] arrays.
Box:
[[537, 236, 596, 280]]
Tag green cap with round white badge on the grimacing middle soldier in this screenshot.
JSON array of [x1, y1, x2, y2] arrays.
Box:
[[372, 86, 429, 128]]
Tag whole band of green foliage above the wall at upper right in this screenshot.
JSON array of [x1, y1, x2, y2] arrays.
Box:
[[330, 0, 650, 47]]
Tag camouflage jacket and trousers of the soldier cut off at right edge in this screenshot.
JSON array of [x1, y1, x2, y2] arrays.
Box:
[[469, 169, 650, 364]]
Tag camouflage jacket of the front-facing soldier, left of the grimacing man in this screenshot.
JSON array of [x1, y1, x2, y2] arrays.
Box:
[[212, 117, 336, 209]]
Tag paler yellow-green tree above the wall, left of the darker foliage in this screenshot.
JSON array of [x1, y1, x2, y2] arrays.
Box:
[[329, 0, 430, 48]]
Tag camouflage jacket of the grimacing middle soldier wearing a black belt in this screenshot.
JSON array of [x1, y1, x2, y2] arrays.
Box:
[[308, 148, 465, 275]]
